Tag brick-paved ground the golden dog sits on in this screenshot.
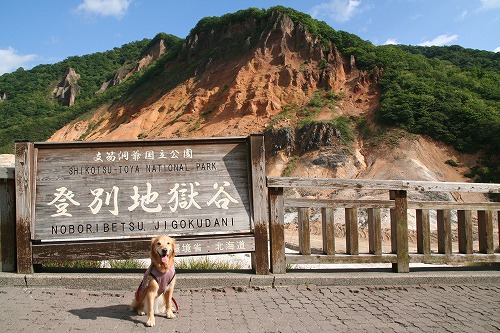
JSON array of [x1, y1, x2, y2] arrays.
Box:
[[0, 284, 500, 333]]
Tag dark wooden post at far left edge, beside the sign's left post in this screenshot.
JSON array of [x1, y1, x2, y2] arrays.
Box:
[[0, 155, 16, 272]]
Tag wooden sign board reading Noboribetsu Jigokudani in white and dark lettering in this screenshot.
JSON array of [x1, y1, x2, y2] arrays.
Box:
[[32, 138, 253, 241]]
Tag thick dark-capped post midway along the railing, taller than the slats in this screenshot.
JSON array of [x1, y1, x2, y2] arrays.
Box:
[[390, 190, 410, 273]]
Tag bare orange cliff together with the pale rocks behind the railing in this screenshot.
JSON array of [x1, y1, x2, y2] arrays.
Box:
[[50, 12, 476, 197]]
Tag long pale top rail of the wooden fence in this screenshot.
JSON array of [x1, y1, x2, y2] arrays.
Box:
[[267, 177, 500, 193]]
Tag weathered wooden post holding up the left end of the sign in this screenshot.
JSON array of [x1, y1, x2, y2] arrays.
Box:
[[15, 142, 35, 274]]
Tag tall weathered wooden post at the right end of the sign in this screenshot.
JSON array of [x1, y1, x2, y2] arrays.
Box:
[[250, 135, 269, 275]]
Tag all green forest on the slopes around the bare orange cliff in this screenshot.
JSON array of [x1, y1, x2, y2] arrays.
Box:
[[0, 6, 500, 181]]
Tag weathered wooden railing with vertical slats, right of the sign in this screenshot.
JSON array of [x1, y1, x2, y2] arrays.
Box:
[[267, 177, 500, 273]]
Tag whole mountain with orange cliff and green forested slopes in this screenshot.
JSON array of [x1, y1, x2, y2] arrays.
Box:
[[0, 6, 500, 187]]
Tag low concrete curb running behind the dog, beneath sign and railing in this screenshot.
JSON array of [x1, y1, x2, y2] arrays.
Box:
[[0, 268, 500, 291]]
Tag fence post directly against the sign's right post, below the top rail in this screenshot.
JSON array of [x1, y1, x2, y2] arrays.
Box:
[[268, 187, 286, 274]]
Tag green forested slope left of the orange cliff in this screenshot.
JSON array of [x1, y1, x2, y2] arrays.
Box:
[[0, 33, 180, 153]]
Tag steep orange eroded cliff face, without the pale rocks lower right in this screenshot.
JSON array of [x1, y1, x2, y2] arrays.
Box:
[[51, 12, 378, 141]]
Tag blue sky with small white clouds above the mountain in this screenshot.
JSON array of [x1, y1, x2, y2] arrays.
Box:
[[0, 0, 500, 75]]
